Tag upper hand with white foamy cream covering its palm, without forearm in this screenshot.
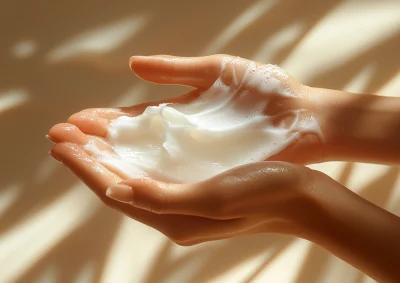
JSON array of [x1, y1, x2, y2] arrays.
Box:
[[49, 55, 324, 183]]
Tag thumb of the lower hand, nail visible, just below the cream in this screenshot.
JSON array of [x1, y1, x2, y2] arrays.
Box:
[[106, 179, 244, 220]]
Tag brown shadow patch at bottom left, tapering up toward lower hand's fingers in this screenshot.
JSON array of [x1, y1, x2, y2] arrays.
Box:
[[16, 208, 121, 283]]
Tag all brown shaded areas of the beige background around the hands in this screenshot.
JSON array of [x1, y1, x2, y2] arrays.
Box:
[[0, 0, 400, 283]]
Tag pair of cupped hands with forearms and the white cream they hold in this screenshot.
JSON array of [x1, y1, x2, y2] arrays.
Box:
[[49, 55, 400, 282]]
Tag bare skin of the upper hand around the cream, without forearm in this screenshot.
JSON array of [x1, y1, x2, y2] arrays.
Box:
[[49, 55, 322, 169]]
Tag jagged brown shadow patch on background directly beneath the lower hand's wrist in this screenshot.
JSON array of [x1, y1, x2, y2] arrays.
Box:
[[144, 235, 293, 283]]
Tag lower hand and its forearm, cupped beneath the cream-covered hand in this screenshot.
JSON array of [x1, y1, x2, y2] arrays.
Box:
[[51, 135, 400, 282]]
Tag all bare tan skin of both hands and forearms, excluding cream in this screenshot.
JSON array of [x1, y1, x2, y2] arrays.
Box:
[[49, 55, 400, 282]]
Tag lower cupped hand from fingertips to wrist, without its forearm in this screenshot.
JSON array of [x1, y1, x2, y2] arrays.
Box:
[[52, 136, 315, 246]]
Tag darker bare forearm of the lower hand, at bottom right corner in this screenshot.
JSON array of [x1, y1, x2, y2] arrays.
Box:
[[303, 177, 400, 282]]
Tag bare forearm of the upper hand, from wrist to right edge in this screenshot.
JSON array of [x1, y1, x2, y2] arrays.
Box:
[[305, 87, 400, 164]]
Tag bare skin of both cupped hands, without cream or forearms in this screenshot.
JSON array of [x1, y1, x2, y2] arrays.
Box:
[[48, 55, 320, 245]]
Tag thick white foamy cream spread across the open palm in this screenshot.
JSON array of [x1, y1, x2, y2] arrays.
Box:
[[86, 62, 322, 183]]
